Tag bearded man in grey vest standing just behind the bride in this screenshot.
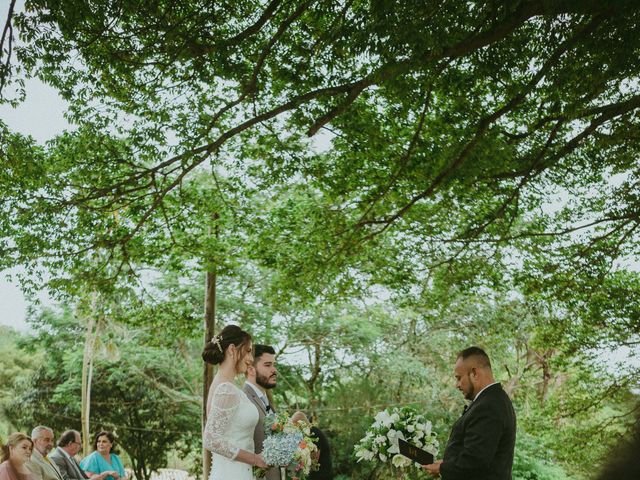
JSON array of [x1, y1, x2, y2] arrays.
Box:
[[243, 344, 280, 480]]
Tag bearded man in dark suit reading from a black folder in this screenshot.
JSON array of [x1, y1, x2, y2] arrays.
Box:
[[422, 347, 516, 480]]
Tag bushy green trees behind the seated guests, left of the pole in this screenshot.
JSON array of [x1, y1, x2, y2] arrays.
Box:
[[7, 310, 200, 479]]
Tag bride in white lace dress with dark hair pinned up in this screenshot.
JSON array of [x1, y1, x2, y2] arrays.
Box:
[[202, 325, 268, 480]]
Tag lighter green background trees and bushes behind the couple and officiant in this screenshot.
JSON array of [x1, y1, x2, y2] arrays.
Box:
[[2, 260, 639, 479]]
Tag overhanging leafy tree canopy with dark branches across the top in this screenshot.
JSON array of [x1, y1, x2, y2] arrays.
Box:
[[0, 0, 639, 294]]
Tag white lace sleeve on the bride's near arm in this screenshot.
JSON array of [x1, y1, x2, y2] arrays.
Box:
[[204, 383, 240, 460]]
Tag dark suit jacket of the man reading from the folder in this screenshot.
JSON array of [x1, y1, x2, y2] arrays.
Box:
[[440, 384, 516, 480]]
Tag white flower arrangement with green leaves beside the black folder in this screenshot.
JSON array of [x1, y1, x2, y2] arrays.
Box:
[[355, 407, 438, 469]]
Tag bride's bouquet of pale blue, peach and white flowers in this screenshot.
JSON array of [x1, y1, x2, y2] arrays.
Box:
[[256, 413, 319, 480]]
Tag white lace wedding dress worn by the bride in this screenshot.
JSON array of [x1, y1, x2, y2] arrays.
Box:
[[203, 382, 259, 480]]
